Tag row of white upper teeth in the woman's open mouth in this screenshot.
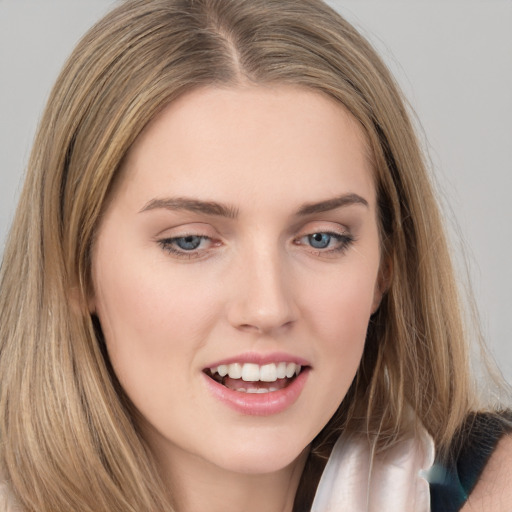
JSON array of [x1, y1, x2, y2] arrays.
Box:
[[210, 363, 301, 382]]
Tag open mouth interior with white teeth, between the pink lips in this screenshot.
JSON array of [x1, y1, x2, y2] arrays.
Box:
[[204, 362, 305, 393]]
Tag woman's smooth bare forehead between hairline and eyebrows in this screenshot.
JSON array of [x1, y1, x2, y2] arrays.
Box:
[[117, 85, 374, 212]]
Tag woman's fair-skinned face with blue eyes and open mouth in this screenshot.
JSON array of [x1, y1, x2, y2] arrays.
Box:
[[91, 86, 381, 480]]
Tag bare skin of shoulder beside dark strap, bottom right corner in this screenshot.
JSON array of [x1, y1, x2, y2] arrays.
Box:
[[461, 434, 512, 512]]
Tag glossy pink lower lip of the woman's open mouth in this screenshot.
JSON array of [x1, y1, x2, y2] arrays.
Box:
[[203, 368, 309, 416]]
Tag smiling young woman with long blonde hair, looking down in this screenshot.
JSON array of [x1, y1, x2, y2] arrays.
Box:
[[0, 0, 512, 512]]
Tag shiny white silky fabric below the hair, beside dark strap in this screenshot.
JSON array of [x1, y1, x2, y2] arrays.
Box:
[[311, 432, 434, 512]]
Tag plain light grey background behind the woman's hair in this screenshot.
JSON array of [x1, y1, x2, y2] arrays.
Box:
[[0, 0, 512, 382]]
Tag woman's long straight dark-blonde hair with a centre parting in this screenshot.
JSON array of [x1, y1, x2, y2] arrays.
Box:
[[0, 0, 496, 512]]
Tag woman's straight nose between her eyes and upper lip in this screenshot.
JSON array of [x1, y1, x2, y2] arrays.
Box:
[[228, 245, 298, 335]]
